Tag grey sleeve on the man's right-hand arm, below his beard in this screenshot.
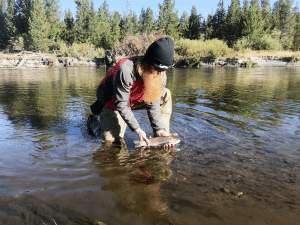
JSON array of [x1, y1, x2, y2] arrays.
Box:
[[147, 75, 167, 133]]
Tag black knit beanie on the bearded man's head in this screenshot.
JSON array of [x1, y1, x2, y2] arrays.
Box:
[[144, 37, 174, 70]]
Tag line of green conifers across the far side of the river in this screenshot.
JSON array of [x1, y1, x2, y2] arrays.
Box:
[[0, 0, 300, 51]]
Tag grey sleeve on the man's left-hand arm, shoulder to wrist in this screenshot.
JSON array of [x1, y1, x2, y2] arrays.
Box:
[[113, 66, 140, 131]]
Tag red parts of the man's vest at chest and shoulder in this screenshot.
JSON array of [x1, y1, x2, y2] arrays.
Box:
[[101, 56, 145, 110]]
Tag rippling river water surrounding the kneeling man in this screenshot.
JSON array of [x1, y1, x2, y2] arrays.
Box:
[[0, 67, 300, 225]]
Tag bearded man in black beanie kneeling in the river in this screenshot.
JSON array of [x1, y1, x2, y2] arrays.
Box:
[[88, 38, 176, 148]]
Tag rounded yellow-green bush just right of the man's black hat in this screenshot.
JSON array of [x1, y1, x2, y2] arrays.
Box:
[[175, 39, 234, 63]]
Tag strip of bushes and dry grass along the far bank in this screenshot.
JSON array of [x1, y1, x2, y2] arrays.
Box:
[[0, 37, 300, 64]]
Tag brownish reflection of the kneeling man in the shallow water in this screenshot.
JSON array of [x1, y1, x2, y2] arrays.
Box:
[[93, 140, 176, 224]]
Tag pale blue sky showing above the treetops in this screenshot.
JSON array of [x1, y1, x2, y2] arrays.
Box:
[[60, 0, 276, 19]]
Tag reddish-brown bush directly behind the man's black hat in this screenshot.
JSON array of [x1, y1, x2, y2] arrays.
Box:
[[113, 31, 164, 57]]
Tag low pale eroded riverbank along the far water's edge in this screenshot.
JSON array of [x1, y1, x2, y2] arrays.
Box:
[[0, 52, 300, 68]]
